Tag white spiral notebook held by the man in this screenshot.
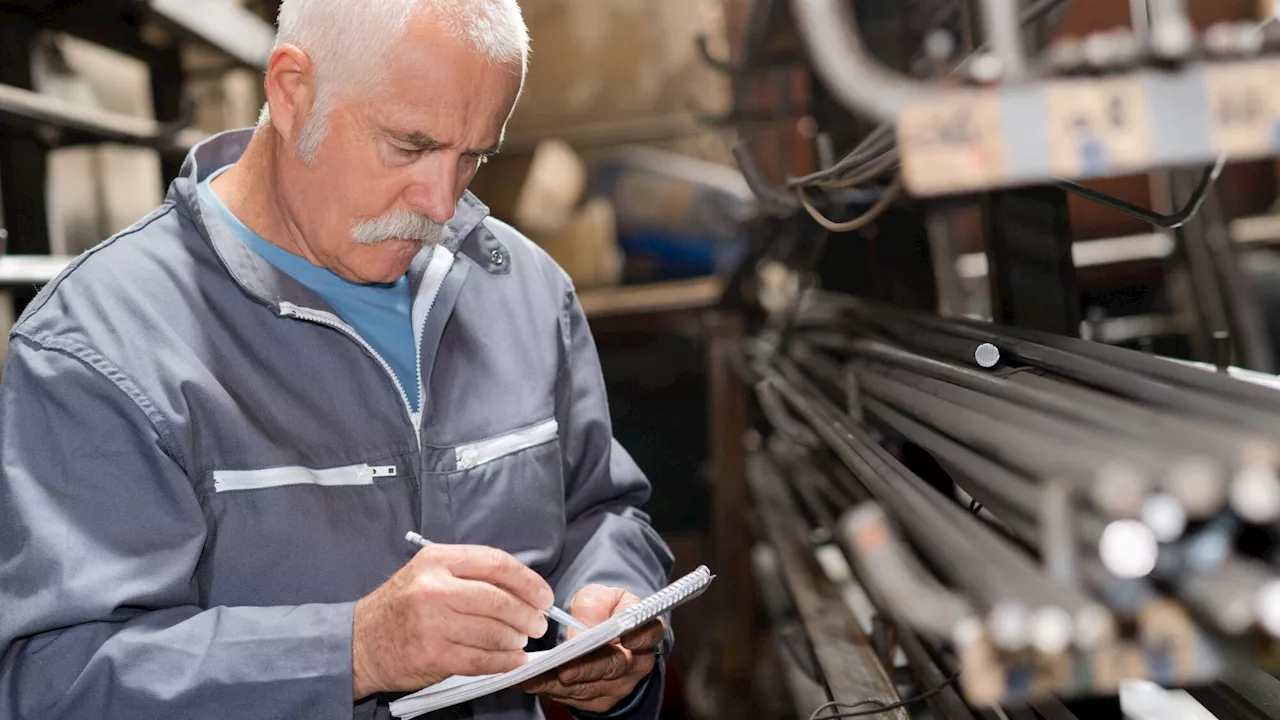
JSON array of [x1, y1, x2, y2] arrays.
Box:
[[392, 565, 716, 720]]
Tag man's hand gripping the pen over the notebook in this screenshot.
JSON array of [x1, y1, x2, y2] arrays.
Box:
[[351, 544, 554, 700]]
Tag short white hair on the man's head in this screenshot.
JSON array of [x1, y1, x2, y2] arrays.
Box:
[[259, 0, 529, 163]]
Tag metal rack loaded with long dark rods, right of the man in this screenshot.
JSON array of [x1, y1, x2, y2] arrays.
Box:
[[710, 0, 1280, 720]]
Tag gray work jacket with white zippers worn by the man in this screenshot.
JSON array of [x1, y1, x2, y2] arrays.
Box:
[[0, 131, 671, 720]]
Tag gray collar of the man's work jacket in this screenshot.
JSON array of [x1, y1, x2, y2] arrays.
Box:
[[168, 128, 489, 309]]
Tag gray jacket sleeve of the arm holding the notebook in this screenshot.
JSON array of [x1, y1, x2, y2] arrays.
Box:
[[549, 290, 672, 719]]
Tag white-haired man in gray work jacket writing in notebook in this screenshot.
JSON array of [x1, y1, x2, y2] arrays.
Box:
[[0, 0, 671, 720]]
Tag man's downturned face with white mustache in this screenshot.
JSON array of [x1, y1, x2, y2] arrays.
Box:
[[280, 18, 520, 282]]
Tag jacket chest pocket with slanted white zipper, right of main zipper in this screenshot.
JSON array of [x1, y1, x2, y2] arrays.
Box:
[[426, 419, 564, 573]]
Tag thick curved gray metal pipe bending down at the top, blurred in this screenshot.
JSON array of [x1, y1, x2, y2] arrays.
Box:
[[791, 0, 928, 123]]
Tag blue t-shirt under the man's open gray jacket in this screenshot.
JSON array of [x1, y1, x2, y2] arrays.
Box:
[[200, 165, 419, 413]]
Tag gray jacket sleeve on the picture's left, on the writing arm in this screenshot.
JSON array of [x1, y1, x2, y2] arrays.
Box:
[[0, 337, 355, 720]]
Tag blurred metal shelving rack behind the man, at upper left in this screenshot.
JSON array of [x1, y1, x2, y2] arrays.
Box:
[[0, 0, 274, 255]]
